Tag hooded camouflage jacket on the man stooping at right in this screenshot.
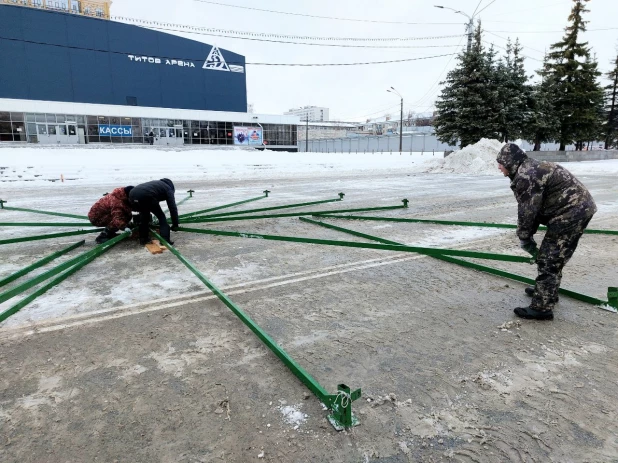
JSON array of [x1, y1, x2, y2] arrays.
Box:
[[497, 143, 597, 240]]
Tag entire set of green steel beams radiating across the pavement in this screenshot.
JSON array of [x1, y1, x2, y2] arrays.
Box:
[[0, 190, 618, 430]]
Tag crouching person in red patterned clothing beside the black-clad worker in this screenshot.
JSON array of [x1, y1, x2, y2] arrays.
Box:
[[88, 186, 133, 244]]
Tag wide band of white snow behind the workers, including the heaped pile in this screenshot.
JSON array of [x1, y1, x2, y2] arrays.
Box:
[[0, 139, 618, 188]]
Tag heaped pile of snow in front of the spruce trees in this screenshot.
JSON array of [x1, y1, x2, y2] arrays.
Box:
[[416, 138, 504, 175]]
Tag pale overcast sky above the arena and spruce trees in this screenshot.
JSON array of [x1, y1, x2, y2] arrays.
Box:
[[111, 0, 618, 120]]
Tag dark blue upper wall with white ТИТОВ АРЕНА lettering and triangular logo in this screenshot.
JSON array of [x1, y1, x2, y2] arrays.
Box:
[[0, 5, 247, 112]]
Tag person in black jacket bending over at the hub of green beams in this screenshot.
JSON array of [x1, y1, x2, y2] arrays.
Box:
[[129, 178, 178, 244]]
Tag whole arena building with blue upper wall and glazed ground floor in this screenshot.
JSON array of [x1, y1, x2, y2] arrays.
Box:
[[0, 0, 299, 150]]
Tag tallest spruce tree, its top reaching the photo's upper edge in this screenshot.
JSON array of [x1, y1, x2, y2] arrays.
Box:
[[542, 0, 603, 151]]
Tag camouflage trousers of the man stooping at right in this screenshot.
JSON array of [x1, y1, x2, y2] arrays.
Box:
[[530, 217, 592, 310]]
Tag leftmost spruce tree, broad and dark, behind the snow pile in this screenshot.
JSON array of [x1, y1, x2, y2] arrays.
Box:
[[434, 23, 500, 148]]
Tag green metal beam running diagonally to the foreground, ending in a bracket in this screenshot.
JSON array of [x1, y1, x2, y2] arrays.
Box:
[[152, 230, 361, 430]]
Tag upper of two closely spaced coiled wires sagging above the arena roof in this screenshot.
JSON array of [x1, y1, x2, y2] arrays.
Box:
[[112, 16, 461, 42]]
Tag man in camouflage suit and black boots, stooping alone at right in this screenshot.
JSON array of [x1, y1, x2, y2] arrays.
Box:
[[497, 143, 597, 320]]
